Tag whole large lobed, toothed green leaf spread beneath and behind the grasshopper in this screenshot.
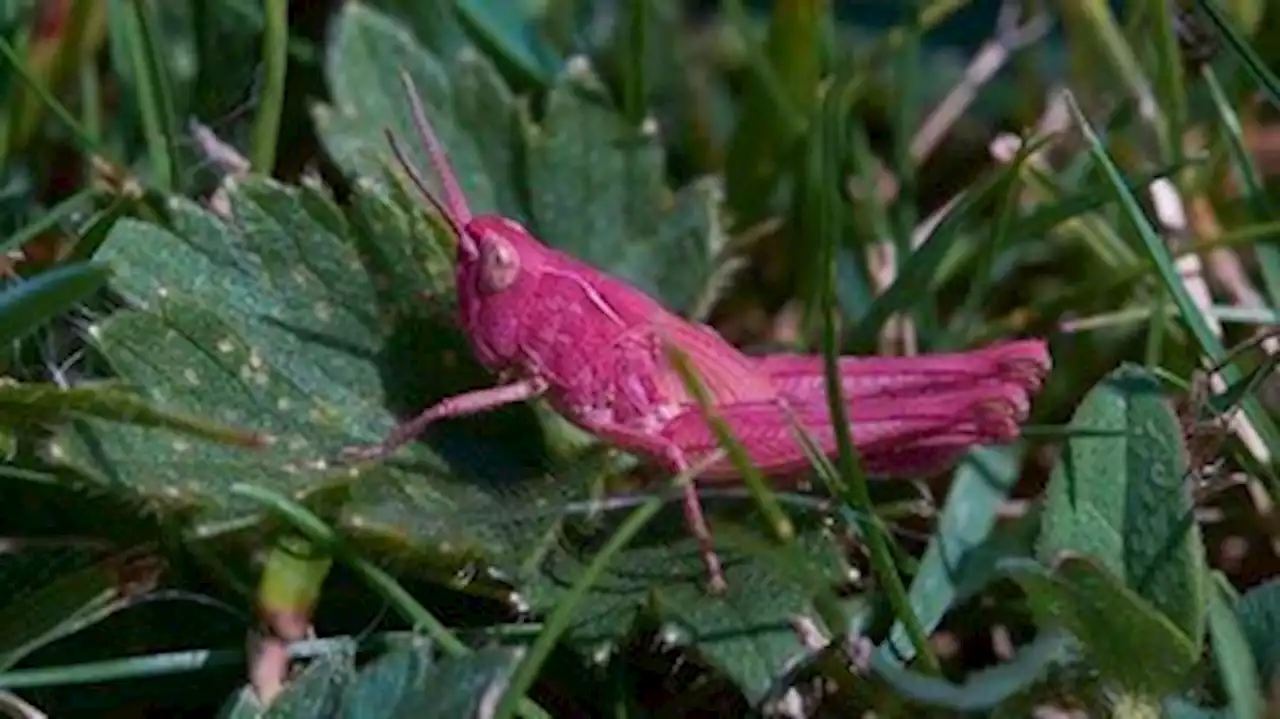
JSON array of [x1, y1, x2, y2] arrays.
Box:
[[70, 5, 841, 696]]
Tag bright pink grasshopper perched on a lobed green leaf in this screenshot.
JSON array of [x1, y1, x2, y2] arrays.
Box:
[[344, 73, 1050, 591]]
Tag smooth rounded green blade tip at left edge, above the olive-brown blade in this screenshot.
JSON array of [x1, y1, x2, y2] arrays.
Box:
[[0, 264, 109, 345]]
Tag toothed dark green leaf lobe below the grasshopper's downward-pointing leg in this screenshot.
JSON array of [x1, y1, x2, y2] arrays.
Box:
[[526, 500, 842, 702]]
